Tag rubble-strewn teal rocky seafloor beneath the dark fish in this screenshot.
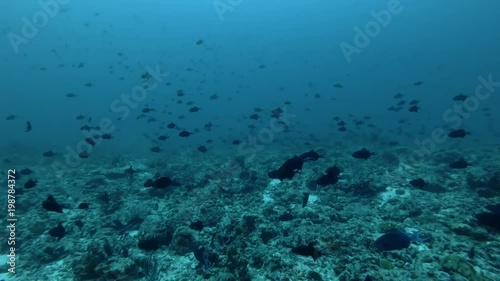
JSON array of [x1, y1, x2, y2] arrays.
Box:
[[1, 143, 500, 281]]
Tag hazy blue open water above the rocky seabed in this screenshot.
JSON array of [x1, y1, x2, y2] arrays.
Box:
[[0, 0, 500, 280]]
